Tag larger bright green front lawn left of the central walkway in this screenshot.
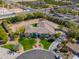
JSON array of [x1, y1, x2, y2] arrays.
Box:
[[19, 38, 36, 50]]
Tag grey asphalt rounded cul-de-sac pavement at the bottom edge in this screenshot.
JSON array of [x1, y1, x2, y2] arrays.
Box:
[[16, 50, 55, 59]]
